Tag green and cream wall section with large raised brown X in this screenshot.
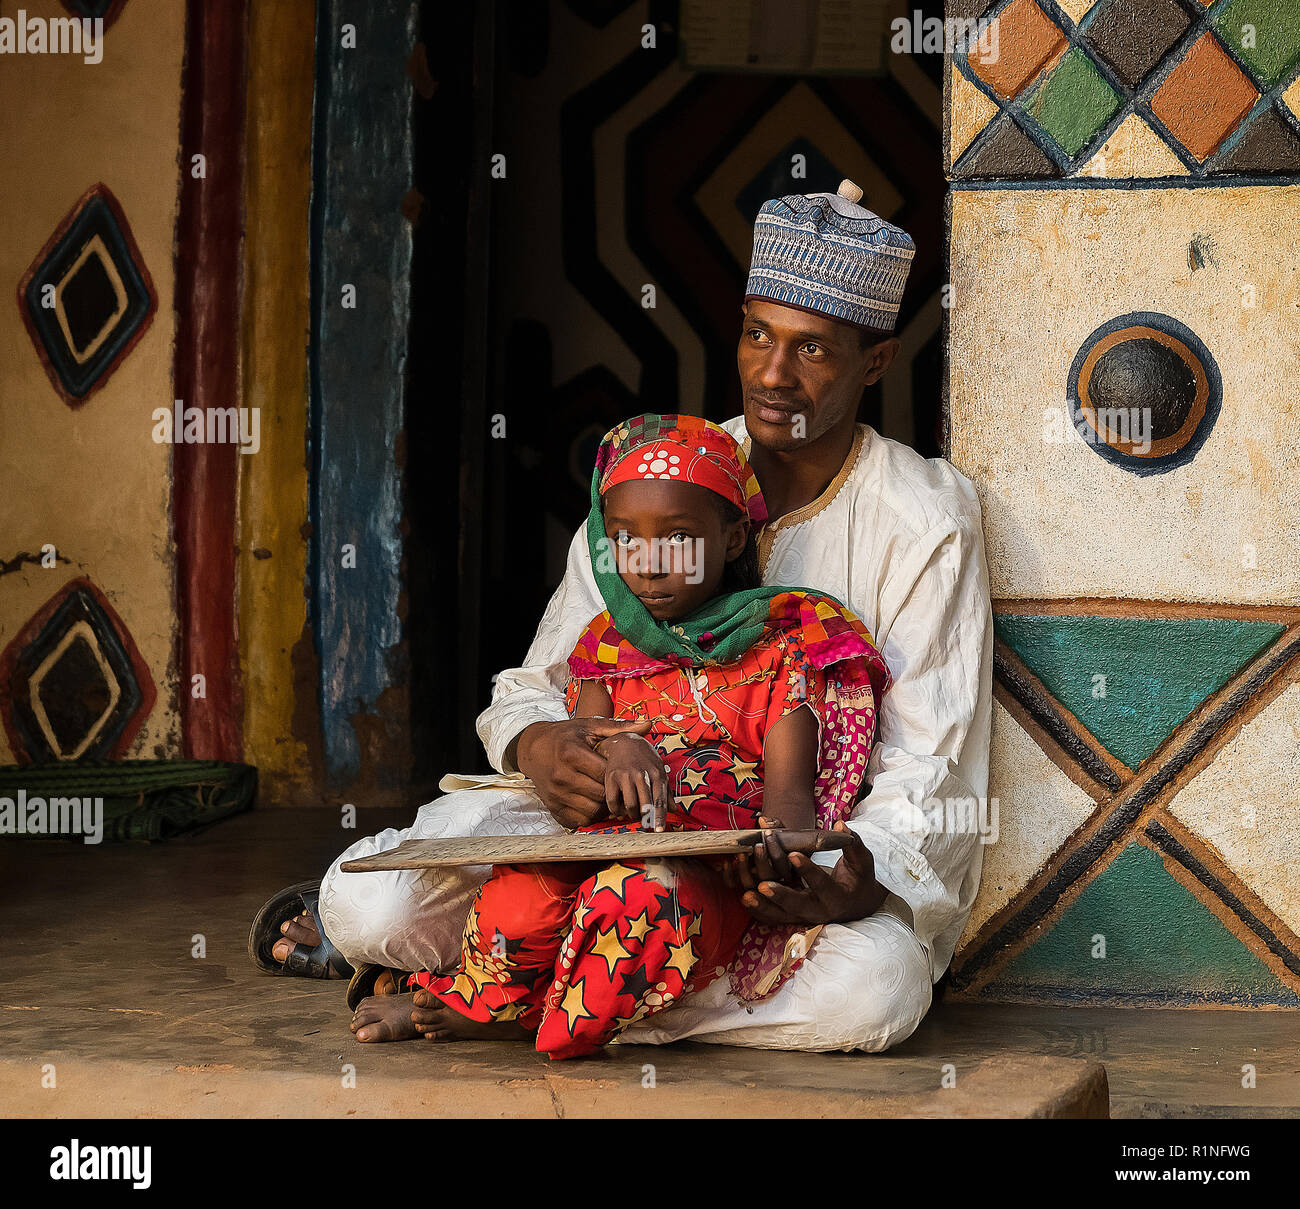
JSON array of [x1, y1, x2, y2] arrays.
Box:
[[952, 601, 1300, 1006]]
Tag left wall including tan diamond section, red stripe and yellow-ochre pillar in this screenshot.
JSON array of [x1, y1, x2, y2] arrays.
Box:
[[0, 0, 320, 802]]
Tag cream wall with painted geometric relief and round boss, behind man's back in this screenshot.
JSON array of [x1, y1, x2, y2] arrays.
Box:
[[945, 0, 1300, 1008]]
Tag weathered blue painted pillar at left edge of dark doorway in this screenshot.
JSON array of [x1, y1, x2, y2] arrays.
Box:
[[311, 0, 413, 787]]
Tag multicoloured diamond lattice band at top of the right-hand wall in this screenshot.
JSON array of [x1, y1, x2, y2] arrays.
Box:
[[950, 0, 1300, 181]]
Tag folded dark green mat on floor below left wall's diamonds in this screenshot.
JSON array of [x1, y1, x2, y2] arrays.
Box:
[[0, 759, 257, 844]]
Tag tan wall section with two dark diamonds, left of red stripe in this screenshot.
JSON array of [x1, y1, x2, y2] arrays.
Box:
[[0, 0, 185, 763]]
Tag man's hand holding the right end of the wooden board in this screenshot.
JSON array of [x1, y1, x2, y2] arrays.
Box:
[[724, 818, 888, 924]]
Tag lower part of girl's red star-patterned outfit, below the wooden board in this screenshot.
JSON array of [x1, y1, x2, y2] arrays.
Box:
[[410, 859, 749, 1058]]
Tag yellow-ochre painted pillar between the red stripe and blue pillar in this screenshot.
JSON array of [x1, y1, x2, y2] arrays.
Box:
[[239, 0, 320, 800]]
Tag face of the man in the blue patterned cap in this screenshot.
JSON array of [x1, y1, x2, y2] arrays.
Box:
[[736, 298, 898, 451]]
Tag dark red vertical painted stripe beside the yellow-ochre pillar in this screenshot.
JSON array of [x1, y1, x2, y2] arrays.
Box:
[[172, 0, 245, 761]]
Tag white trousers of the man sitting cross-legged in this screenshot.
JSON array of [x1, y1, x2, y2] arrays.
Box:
[[320, 787, 932, 1053]]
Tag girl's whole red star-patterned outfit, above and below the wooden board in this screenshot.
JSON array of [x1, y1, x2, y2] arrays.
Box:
[[411, 592, 889, 1058]]
